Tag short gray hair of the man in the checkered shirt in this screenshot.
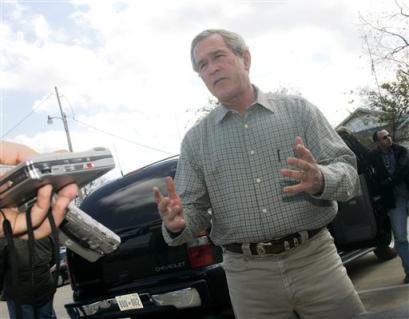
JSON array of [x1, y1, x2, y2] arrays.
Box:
[[190, 29, 248, 72]]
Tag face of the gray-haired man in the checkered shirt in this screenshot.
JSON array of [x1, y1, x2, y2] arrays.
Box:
[[193, 34, 251, 103]]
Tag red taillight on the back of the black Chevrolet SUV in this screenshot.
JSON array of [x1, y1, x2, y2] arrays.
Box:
[[188, 236, 214, 268]]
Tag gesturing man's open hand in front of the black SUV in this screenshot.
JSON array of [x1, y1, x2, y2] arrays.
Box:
[[153, 176, 186, 233]]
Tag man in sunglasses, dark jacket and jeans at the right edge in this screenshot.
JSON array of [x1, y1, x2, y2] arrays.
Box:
[[369, 130, 409, 284]]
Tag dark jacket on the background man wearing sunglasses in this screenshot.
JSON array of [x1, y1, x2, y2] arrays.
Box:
[[368, 144, 409, 208]]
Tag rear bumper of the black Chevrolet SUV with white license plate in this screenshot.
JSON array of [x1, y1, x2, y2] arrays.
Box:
[[65, 269, 230, 319]]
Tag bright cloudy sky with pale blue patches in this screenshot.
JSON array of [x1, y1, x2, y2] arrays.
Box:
[[0, 0, 402, 180]]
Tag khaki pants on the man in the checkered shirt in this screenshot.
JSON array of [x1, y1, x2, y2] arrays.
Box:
[[223, 229, 365, 319]]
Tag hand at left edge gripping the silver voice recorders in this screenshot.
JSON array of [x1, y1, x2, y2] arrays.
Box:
[[0, 141, 78, 238]]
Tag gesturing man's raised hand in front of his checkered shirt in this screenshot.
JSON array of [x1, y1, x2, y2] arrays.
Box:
[[281, 136, 324, 195]]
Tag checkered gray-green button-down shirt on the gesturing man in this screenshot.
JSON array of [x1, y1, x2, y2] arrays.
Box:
[[162, 90, 359, 245]]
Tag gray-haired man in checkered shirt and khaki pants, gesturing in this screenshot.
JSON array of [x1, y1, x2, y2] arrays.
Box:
[[154, 30, 364, 319]]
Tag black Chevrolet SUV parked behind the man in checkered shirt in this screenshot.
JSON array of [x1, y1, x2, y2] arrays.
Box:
[[65, 157, 393, 318]]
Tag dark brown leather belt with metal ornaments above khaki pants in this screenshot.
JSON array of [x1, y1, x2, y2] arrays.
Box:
[[223, 228, 324, 256]]
